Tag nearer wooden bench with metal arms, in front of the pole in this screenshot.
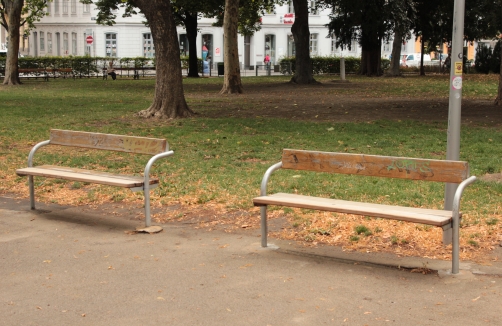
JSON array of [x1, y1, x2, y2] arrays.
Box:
[[253, 149, 476, 274]]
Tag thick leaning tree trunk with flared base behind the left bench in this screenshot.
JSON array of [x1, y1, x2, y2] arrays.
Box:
[[131, 0, 194, 119]]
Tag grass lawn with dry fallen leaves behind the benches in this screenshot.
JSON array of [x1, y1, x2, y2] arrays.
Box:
[[0, 75, 502, 260]]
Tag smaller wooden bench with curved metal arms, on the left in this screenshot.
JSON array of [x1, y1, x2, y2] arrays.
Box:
[[16, 129, 174, 227]]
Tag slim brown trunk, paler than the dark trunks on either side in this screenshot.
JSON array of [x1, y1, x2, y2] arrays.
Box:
[[220, 0, 243, 94]]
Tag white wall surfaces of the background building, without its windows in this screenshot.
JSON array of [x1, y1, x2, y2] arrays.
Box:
[[29, 0, 400, 61]]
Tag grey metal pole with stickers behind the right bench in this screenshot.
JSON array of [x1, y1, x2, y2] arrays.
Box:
[[444, 0, 465, 210]]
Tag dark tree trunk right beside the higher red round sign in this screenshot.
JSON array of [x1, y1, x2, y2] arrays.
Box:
[[291, 0, 316, 84]]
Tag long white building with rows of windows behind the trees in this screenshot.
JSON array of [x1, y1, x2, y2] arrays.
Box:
[[21, 0, 434, 67]]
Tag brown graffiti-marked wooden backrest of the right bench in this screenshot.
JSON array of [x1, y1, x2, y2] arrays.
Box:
[[282, 149, 469, 183]]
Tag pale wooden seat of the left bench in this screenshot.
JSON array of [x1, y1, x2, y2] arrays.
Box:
[[16, 165, 159, 188]]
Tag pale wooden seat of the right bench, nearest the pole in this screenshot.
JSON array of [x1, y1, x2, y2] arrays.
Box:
[[253, 193, 452, 226]]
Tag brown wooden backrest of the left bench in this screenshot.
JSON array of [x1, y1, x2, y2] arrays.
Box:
[[50, 129, 169, 155]]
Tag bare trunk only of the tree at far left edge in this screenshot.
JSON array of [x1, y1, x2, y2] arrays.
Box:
[[3, 0, 24, 85]]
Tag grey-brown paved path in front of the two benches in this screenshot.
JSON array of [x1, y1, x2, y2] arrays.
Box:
[[0, 197, 502, 326]]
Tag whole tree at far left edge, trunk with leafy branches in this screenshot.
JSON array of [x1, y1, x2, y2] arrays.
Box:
[[0, 0, 48, 85]]
